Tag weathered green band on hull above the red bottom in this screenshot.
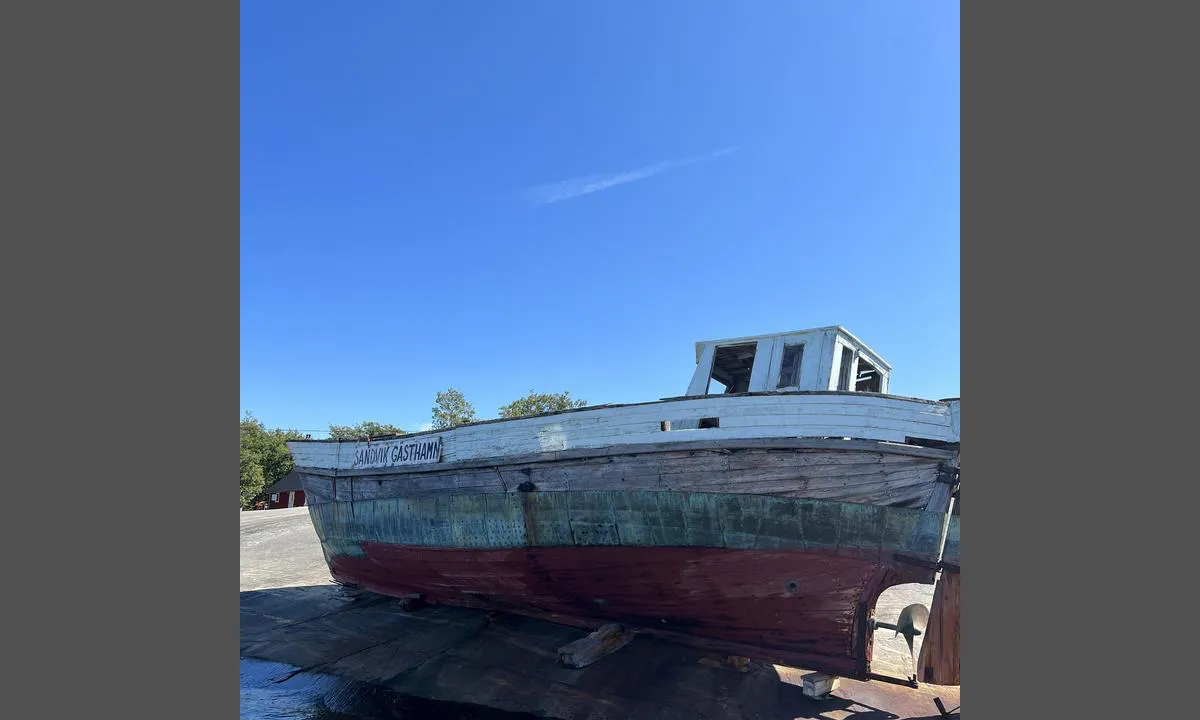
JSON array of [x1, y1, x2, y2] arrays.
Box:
[[308, 491, 958, 559]]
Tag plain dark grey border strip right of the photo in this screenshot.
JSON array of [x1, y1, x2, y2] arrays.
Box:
[[961, 2, 1180, 718]]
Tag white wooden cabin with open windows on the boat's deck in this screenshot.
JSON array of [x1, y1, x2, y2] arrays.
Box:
[[686, 325, 892, 397]]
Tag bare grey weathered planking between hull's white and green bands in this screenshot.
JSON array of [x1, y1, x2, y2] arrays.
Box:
[[298, 439, 955, 509]]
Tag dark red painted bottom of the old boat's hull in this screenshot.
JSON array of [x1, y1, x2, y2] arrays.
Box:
[[330, 542, 926, 678]]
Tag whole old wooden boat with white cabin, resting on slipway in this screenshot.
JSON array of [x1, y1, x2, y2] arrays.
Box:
[[289, 326, 959, 678]]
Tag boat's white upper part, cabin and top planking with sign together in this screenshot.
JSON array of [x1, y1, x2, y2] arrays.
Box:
[[288, 325, 959, 472]]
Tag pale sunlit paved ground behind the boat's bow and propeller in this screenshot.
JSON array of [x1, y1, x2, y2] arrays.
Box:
[[240, 508, 934, 677]]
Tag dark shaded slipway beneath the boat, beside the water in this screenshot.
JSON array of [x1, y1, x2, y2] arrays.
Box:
[[241, 586, 959, 720]]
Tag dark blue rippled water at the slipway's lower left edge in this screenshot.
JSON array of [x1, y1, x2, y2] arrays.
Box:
[[241, 658, 534, 720]]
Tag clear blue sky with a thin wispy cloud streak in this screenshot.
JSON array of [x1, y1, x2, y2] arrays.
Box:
[[240, 0, 959, 432]]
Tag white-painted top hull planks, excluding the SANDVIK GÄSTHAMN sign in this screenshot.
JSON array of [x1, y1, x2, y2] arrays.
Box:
[[288, 394, 958, 469]]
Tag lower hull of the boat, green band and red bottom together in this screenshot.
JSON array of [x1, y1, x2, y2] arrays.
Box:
[[310, 491, 943, 678]]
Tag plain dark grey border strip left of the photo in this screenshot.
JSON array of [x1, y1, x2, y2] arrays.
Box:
[[0, 0, 241, 719]]
